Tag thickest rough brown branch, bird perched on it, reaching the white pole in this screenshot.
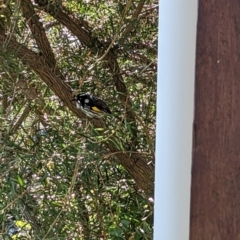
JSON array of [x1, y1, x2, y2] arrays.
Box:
[[0, 31, 154, 196]]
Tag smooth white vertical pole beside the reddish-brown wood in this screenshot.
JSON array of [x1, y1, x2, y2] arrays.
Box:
[[154, 0, 198, 240]]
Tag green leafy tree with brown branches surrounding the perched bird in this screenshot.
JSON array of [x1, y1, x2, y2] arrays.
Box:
[[0, 0, 158, 240]]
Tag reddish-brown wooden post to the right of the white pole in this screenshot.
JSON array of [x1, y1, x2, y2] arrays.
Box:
[[190, 0, 240, 240]]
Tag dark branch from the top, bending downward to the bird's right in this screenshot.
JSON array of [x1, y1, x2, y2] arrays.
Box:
[[35, 0, 138, 142]]
